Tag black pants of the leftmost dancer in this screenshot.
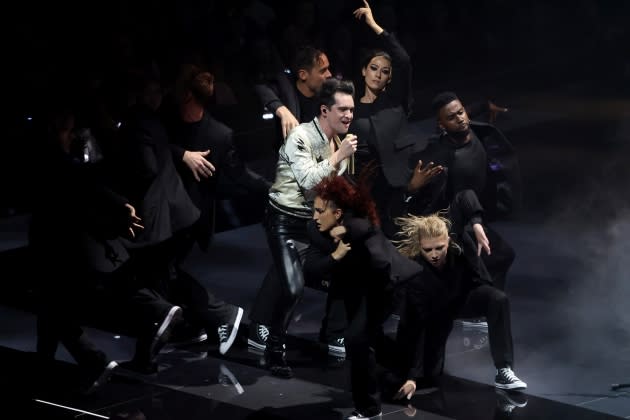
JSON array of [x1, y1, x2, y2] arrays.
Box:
[[37, 260, 172, 369]]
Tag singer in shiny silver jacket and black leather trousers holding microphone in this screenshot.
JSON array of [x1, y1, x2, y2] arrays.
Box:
[[250, 79, 357, 377]]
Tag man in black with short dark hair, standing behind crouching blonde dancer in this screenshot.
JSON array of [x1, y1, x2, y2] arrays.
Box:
[[407, 92, 521, 290]]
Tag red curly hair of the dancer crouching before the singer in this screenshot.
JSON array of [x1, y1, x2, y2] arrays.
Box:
[[312, 173, 381, 226]]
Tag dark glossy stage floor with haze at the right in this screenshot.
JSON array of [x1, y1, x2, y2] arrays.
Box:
[[0, 215, 630, 420]]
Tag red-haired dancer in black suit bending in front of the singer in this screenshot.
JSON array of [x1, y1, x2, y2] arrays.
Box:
[[304, 172, 422, 419]]
